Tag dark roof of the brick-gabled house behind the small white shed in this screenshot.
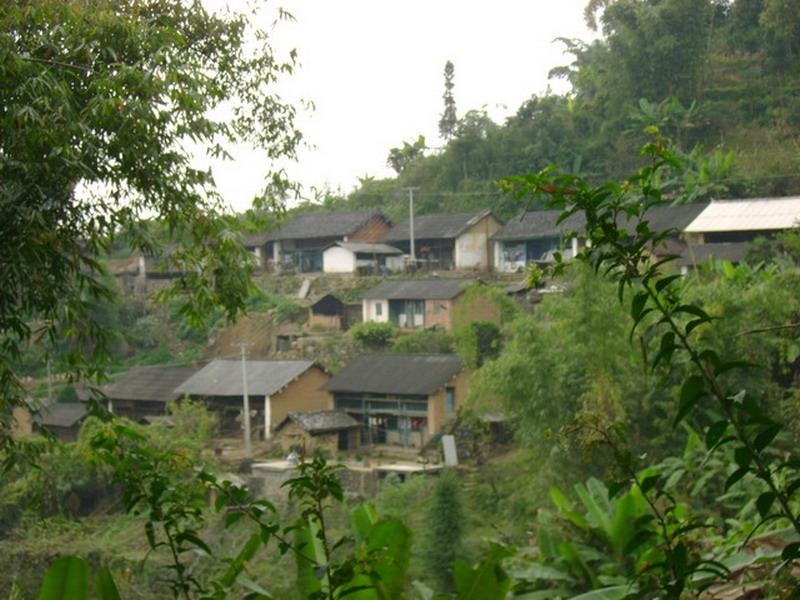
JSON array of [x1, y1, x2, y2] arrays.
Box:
[[245, 211, 382, 248]]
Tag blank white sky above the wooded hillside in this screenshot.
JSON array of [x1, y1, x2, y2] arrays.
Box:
[[213, 0, 591, 210]]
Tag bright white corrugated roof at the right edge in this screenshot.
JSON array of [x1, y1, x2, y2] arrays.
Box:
[[685, 196, 800, 233]]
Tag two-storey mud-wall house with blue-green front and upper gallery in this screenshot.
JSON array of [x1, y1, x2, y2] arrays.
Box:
[[323, 353, 469, 448]]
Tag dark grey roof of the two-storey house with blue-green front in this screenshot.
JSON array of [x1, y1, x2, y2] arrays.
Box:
[[322, 353, 463, 396]]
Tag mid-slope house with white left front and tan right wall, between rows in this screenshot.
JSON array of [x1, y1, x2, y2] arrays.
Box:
[[362, 278, 500, 331]]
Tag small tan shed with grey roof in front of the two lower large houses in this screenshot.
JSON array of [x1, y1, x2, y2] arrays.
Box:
[[275, 410, 361, 454]]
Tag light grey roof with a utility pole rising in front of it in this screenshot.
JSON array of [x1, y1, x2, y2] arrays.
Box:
[[175, 360, 314, 396]]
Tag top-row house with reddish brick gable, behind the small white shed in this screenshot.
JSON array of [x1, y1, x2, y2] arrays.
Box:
[[245, 211, 391, 273]]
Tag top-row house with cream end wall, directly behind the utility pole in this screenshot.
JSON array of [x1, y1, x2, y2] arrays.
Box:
[[381, 210, 503, 271]]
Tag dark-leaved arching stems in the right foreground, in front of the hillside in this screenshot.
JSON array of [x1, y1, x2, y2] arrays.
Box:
[[508, 137, 800, 597]]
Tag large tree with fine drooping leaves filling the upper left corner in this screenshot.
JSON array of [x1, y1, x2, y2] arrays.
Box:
[[0, 0, 301, 460]]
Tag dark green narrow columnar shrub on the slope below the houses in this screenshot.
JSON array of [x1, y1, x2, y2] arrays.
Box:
[[420, 469, 464, 589]]
